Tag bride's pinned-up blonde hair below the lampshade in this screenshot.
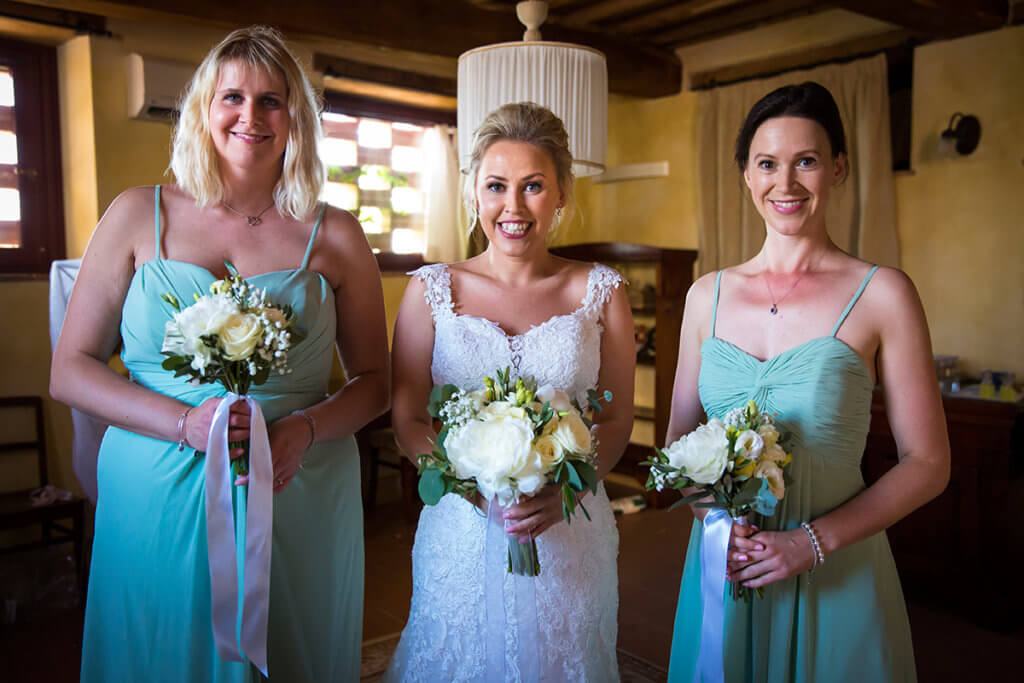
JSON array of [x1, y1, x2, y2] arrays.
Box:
[[462, 102, 575, 242]]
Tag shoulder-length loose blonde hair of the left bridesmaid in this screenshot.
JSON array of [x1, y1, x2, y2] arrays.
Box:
[[170, 26, 327, 220]]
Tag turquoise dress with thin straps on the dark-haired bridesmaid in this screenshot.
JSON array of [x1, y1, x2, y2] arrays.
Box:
[[669, 266, 916, 683]]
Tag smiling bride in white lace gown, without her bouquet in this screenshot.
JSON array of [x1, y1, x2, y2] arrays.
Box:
[[385, 102, 635, 681]]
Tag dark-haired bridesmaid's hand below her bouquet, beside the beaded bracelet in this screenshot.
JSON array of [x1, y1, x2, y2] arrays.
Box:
[[725, 524, 815, 588]]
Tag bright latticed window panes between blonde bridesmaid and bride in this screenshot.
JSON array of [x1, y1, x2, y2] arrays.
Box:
[[321, 112, 426, 254]]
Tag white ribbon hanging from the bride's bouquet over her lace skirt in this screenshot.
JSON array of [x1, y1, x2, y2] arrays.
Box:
[[483, 498, 541, 683]]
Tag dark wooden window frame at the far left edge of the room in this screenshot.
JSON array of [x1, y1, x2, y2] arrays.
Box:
[[0, 37, 66, 276]]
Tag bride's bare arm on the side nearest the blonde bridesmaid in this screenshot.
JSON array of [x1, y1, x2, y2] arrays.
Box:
[[391, 278, 437, 465]]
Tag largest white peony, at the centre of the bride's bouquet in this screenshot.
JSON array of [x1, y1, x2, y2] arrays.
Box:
[[444, 409, 547, 505]]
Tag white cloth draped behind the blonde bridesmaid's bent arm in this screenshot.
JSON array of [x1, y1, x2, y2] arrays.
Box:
[[50, 258, 106, 505]]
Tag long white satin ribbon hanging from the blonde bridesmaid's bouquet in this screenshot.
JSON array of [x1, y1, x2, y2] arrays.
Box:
[[206, 393, 273, 676]]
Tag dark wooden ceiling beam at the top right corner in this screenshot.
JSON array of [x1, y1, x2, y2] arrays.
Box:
[[833, 0, 1010, 38]]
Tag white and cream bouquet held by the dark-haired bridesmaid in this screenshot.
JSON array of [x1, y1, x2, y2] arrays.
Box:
[[643, 400, 793, 600]]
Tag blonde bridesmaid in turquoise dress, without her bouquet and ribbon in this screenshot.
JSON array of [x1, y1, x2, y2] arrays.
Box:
[[51, 27, 388, 683]]
